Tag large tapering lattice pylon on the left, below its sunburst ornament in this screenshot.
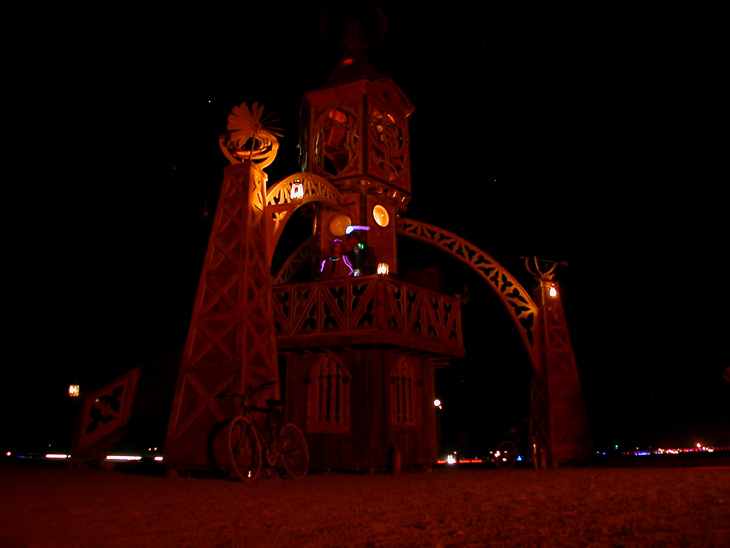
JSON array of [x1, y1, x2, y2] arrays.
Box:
[[165, 162, 278, 465]]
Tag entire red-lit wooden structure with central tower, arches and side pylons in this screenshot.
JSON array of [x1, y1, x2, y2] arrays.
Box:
[[75, 18, 590, 471]]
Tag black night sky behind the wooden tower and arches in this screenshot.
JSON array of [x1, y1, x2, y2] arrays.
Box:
[[2, 2, 730, 449]]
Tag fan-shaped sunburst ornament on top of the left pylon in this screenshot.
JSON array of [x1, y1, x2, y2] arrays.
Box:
[[219, 102, 282, 168]]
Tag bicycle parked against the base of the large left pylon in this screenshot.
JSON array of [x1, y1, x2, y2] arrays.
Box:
[[228, 382, 309, 481]]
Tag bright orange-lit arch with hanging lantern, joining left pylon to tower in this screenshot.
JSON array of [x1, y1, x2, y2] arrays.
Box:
[[266, 173, 343, 263]]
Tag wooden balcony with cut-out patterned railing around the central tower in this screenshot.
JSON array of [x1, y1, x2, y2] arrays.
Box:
[[273, 276, 464, 358]]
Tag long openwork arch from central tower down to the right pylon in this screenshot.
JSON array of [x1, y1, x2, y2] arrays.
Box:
[[396, 218, 541, 374]]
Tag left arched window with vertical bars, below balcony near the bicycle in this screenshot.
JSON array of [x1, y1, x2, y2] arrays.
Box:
[[307, 356, 350, 433]]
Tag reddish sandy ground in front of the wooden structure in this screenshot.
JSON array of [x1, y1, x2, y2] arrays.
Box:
[[0, 464, 730, 547]]
